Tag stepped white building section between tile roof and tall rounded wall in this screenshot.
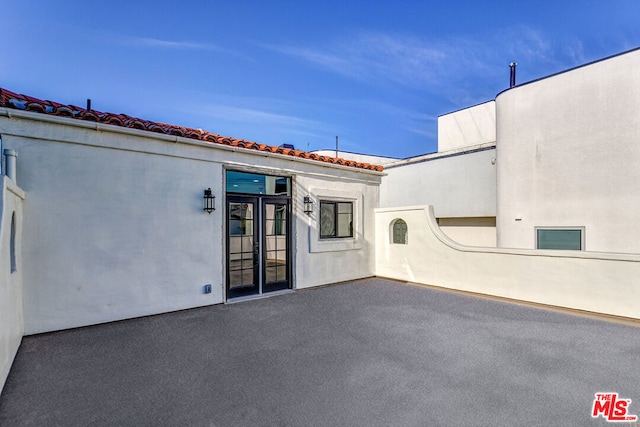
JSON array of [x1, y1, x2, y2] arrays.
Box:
[[380, 101, 496, 247]]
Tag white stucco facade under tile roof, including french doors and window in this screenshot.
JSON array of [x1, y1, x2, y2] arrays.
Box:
[[0, 103, 382, 334]]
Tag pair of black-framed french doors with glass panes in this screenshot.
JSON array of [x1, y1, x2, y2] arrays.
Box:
[[226, 194, 291, 298]]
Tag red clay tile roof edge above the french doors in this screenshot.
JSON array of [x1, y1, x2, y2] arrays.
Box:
[[0, 88, 383, 172]]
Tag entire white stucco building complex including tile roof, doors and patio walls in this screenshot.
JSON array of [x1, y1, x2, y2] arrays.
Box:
[[0, 46, 640, 394]]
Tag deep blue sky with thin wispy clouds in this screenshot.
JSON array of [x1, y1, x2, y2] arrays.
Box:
[[0, 0, 640, 157]]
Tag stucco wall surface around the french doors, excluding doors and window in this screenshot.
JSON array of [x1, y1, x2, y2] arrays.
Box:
[[0, 111, 381, 334]]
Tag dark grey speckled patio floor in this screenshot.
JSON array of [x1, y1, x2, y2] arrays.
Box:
[[0, 279, 640, 426]]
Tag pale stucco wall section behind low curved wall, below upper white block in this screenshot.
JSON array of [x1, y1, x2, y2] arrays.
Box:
[[380, 146, 496, 218]]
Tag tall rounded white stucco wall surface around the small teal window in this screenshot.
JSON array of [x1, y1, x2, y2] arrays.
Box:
[[496, 50, 640, 253]]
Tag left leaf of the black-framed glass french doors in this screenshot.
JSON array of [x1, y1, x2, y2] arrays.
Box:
[[227, 197, 259, 298]]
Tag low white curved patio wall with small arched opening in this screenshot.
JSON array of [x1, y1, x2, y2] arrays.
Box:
[[376, 206, 640, 319]]
